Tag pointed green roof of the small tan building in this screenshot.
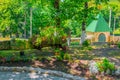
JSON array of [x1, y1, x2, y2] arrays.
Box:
[[86, 14, 111, 32]]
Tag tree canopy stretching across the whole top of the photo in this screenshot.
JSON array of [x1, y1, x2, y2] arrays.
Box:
[[0, 0, 120, 38]]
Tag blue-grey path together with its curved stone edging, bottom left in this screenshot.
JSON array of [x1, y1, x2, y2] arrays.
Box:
[[0, 66, 85, 80]]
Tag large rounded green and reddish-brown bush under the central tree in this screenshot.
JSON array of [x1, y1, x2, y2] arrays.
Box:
[[29, 27, 67, 50]]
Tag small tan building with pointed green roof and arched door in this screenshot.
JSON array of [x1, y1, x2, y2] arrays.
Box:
[[86, 14, 111, 42]]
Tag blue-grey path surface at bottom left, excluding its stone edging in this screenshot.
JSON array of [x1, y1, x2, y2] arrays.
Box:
[[0, 72, 68, 80]]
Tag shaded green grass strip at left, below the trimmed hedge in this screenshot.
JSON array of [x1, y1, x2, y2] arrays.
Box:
[[0, 49, 53, 62]]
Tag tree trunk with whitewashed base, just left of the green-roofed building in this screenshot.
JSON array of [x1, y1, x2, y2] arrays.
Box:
[[80, 1, 88, 44]]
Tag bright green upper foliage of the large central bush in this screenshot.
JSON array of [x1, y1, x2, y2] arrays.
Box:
[[40, 27, 67, 44]]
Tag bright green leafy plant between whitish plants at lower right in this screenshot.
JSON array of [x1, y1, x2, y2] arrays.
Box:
[[97, 58, 115, 74]]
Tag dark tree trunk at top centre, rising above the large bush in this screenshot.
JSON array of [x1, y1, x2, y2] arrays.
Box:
[[54, 0, 60, 27]]
